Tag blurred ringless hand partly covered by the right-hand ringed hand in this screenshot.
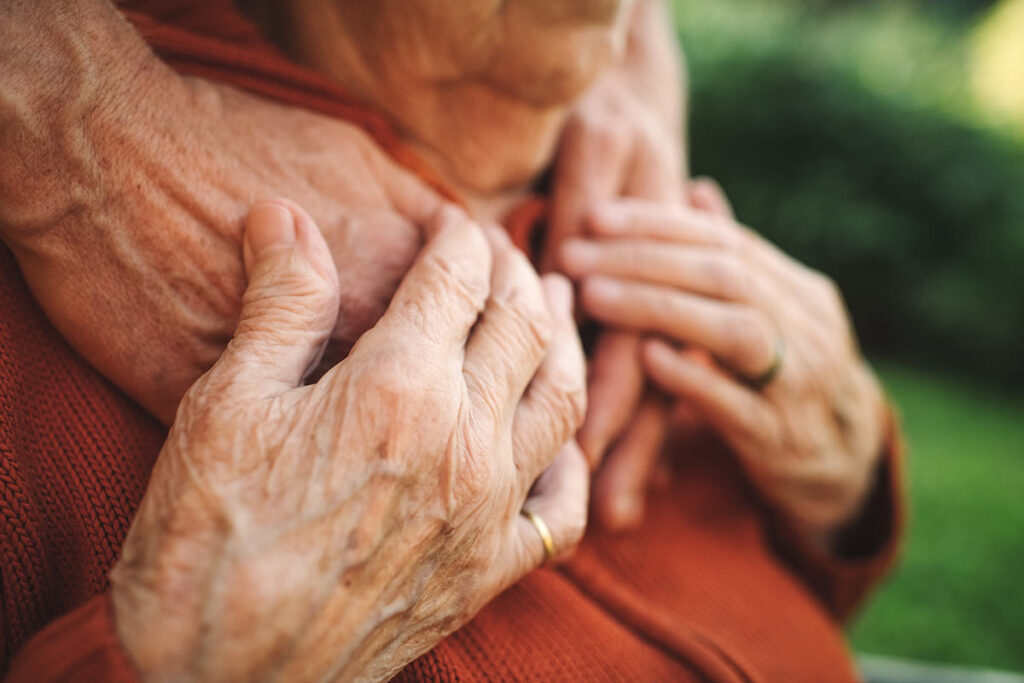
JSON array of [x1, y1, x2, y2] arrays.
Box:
[[543, 0, 685, 526]]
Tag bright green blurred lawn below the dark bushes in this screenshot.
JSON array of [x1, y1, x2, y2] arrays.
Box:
[[851, 365, 1024, 672]]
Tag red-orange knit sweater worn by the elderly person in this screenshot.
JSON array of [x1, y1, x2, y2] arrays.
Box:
[[0, 0, 902, 682]]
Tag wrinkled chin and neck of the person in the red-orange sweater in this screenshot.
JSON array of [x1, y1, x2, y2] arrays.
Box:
[[250, 0, 632, 214]]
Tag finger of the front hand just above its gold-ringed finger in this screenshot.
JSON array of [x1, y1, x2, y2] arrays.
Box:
[[512, 275, 587, 484]]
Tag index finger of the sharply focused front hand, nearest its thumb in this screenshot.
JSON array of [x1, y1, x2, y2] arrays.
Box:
[[372, 206, 492, 360]]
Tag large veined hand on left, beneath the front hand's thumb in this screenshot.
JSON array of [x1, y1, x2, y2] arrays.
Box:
[[0, 63, 440, 423]]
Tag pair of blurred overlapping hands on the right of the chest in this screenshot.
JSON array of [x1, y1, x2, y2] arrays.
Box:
[[542, 68, 886, 545]]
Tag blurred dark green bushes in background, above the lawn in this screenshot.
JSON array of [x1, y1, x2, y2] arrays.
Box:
[[676, 0, 1024, 382]]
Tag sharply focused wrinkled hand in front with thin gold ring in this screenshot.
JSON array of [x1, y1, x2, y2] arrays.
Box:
[[112, 201, 588, 681]]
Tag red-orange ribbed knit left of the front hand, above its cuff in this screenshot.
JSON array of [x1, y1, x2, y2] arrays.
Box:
[[0, 248, 165, 663]]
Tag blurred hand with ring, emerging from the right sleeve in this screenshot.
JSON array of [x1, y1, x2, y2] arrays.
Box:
[[562, 181, 884, 535]]
